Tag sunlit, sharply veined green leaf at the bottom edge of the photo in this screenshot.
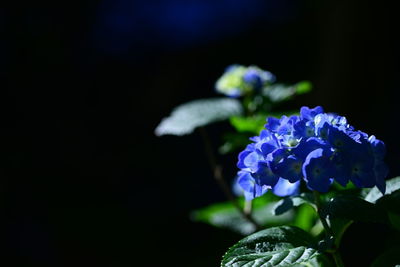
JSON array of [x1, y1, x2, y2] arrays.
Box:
[[221, 226, 330, 267]]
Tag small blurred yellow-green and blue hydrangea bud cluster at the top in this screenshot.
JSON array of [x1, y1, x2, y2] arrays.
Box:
[[215, 64, 275, 98]]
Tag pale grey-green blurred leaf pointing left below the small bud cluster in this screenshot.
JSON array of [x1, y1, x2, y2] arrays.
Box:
[[155, 98, 243, 136]]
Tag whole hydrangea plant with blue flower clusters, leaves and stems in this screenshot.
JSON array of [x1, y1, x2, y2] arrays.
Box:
[[155, 65, 400, 267]]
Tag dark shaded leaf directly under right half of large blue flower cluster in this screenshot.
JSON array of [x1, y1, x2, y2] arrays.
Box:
[[321, 194, 387, 223]]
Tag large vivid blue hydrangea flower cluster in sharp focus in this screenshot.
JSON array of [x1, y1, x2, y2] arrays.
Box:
[[237, 106, 388, 199]]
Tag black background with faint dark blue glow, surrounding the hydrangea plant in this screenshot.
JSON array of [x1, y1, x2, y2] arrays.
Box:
[[0, 0, 400, 266]]
